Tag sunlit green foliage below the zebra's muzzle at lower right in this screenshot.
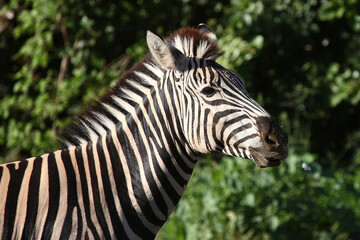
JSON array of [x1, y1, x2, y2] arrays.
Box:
[[158, 149, 360, 240]]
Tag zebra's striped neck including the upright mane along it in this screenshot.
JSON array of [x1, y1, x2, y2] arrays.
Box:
[[60, 56, 197, 239]]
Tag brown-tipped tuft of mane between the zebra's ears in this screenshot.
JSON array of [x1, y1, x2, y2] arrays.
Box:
[[166, 28, 222, 60]]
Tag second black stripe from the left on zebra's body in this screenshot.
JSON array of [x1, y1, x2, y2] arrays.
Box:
[[22, 157, 43, 238]]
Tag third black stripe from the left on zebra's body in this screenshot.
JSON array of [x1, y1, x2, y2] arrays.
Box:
[[42, 152, 60, 239]]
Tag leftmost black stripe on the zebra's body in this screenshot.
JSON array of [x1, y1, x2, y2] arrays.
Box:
[[1, 160, 28, 239]]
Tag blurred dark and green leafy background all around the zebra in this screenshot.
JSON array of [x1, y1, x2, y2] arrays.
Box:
[[0, 0, 360, 239]]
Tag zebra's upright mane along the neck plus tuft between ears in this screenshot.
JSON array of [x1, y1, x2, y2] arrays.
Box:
[[59, 25, 222, 147]]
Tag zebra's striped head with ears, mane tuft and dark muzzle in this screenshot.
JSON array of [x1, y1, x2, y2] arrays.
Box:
[[147, 24, 288, 167]]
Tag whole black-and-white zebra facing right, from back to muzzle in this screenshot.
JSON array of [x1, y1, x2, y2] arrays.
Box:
[[0, 24, 288, 239]]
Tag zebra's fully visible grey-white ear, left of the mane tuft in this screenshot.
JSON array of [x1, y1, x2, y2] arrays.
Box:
[[146, 31, 186, 71]]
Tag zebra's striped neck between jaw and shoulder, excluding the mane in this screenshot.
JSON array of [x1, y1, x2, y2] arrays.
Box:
[[81, 69, 196, 236]]
